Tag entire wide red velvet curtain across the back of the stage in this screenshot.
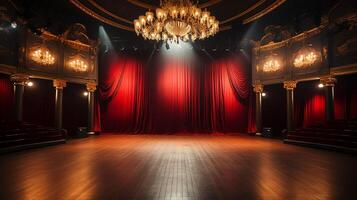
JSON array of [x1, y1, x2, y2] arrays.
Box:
[[99, 54, 250, 133]]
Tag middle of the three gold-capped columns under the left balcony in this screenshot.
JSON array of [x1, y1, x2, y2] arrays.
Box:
[[53, 80, 66, 129]]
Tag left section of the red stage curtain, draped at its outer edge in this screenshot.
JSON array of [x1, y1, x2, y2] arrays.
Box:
[[99, 59, 148, 132]]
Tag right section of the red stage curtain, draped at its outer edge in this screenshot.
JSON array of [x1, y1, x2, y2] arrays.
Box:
[[204, 59, 249, 132]]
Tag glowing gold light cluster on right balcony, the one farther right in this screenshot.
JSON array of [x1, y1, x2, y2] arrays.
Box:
[[293, 45, 321, 68]]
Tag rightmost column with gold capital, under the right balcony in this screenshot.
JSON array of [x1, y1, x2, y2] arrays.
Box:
[[320, 76, 336, 121]]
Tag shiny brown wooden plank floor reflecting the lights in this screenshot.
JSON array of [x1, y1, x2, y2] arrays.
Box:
[[0, 135, 357, 200]]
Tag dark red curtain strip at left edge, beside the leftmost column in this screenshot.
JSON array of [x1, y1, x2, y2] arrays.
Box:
[[0, 74, 13, 121]]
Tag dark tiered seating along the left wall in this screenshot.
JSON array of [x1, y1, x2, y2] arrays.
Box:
[[0, 122, 66, 153]]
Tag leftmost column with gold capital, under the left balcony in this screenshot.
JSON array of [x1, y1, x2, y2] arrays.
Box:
[[10, 74, 29, 121]]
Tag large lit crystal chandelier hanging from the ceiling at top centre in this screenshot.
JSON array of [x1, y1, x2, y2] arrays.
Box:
[[134, 0, 219, 42]]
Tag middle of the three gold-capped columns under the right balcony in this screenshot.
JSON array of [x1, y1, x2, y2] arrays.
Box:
[[284, 81, 297, 130]]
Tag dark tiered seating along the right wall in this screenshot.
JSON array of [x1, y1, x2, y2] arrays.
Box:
[[284, 120, 357, 153]]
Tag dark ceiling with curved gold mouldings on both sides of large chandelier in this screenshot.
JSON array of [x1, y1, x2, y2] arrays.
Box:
[[69, 0, 286, 31]]
